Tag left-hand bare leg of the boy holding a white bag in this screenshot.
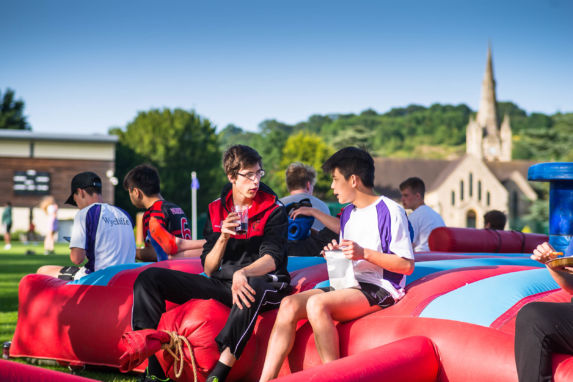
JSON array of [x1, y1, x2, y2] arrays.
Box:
[[260, 289, 324, 382]]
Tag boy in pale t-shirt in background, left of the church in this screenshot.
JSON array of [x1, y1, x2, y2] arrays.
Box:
[[400, 177, 445, 252]]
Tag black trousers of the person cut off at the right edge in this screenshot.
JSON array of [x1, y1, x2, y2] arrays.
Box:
[[515, 302, 573, 382]]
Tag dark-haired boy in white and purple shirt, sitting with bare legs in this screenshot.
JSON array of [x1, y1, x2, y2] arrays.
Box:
[[260, 147, 414, 381]]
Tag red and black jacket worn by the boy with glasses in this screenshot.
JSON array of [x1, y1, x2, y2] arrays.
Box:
[[201, 183, 290, 282]]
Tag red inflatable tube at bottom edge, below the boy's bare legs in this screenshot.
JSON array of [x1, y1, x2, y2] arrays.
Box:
[[276, 337, 439, 382]]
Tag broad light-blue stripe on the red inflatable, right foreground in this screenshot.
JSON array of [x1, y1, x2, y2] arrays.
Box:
[[420, 269, 559, 326]]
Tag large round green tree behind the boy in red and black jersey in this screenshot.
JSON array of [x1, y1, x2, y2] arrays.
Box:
[[110, 109, 225, 219]]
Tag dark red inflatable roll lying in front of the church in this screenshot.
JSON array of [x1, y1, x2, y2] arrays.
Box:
[[428, 227, 549, 253]]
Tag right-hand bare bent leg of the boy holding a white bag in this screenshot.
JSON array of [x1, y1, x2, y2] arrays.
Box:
[[306, 288, 380, 363]]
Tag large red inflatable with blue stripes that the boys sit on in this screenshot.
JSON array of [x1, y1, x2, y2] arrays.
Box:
[[7, 245, 573, 382]]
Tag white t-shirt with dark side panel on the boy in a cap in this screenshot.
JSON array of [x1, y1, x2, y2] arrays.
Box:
[[70, 203, 135, 273]]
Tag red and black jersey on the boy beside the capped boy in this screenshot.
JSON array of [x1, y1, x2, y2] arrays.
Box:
[[143, 200, 191, 245]]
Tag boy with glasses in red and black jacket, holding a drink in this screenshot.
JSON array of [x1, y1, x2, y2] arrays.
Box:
[[132, 145, 290, 382]]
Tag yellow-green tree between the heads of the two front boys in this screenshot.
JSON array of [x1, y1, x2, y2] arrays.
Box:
[[277, 132, 334, 199]]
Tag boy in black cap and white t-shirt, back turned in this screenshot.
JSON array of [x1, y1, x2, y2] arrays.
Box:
[[37, 172, 135, 280]]
